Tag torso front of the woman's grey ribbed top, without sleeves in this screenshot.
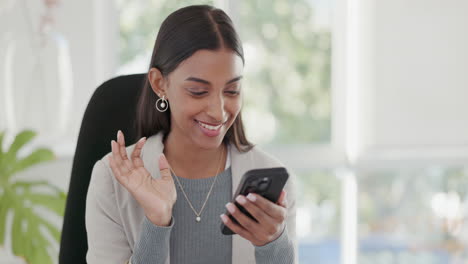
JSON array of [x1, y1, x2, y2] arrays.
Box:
[[170, 165, 232, 263]]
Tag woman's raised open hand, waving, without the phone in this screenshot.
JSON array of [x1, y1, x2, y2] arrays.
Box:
[[109, 130, 177, 226]]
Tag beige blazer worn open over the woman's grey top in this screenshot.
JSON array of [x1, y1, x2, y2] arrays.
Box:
[[86, 133, 298, 264]]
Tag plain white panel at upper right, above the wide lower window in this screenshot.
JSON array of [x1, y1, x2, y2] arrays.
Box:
[[353, 0, 468, 165]]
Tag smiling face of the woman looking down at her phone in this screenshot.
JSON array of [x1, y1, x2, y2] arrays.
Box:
[[166, 49, 243, 149]]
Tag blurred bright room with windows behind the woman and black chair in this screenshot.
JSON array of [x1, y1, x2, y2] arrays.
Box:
[[0, 0, 468, 264]]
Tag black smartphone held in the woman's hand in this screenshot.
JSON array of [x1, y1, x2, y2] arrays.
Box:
[[221, 167, 289, 235]]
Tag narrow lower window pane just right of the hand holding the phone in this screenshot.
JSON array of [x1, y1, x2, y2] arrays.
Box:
[[296, 170, 341, 263]]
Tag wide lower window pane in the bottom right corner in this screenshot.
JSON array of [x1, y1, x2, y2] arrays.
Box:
[[358, 166, 468, 264]]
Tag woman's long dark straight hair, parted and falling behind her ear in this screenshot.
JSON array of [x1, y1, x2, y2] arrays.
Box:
[[136, 5, 253, 152]]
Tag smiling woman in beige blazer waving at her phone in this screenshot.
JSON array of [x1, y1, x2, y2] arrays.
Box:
[[86, 6, 297, 264]]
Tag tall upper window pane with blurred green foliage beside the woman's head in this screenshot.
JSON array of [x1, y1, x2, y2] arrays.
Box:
[[235, 0, 331, 145]]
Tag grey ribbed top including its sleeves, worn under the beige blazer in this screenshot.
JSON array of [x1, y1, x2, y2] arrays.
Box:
[[131, 162, 294, 264]]
